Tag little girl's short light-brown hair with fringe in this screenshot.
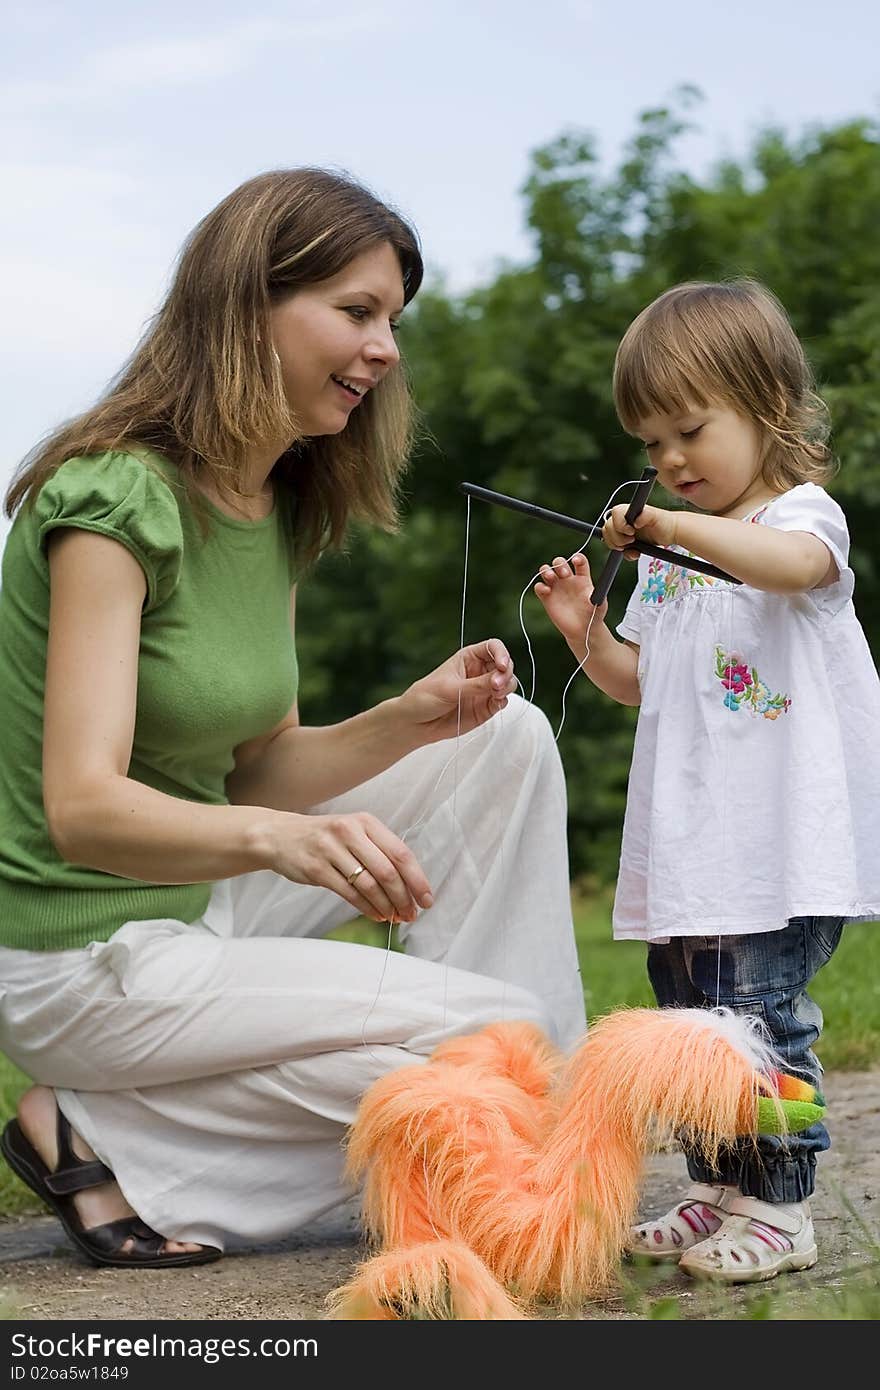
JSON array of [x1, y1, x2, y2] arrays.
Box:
[[613, 278, 837, 492]]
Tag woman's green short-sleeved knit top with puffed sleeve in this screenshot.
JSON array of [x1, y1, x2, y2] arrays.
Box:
[[0, 453, 298, 951]]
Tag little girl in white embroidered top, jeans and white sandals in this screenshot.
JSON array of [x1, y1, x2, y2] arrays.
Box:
[[535, 279, 880, 1283]]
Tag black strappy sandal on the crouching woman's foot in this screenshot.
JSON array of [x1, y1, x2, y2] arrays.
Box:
[[0, 1108, 222, 1269]]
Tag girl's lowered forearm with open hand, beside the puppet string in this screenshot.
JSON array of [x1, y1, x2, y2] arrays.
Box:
[[534, 550, 641, 705]]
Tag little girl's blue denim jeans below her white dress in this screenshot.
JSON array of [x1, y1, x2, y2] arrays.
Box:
[[648, 917, 847, 1202]]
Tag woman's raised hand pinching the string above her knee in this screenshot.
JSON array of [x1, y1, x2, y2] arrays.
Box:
[[398, 637, 516, 744]]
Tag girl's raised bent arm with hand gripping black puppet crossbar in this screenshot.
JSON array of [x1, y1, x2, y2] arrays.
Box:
[[602, 506, 837, 594]]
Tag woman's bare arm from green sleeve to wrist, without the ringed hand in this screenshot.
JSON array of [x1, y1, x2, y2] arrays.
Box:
[[43, 528, 276, 883]]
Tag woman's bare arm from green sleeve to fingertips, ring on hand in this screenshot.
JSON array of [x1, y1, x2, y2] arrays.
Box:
[[43, 528, 431, 922]]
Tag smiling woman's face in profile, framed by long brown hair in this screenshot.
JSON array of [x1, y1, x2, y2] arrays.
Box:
[[270, 242, 403, 435]]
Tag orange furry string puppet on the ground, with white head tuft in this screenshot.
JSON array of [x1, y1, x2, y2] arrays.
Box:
[[334, 1009, 779, 1318]]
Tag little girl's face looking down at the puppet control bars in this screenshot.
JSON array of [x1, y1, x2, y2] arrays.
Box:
[[635, 404, 776, 517]]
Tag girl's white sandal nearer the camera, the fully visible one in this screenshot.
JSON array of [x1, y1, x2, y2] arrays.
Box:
[[678, 1195, 817, 1284]]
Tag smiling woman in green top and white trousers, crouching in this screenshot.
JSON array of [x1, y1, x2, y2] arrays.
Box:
[[0, 168, 584, 1266]]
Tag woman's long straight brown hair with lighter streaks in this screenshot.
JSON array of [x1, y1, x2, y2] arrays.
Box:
[[6, 168, 423, 567]]
